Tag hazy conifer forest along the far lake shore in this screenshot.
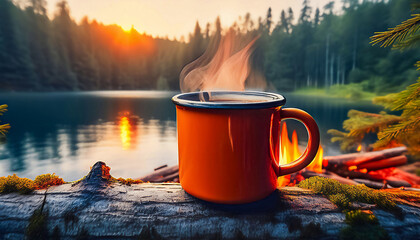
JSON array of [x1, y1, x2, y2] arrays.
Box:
[[0, 0, 419, 93]]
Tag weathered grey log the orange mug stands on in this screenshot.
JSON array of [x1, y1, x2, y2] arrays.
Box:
[[0, 163, 420, 240]]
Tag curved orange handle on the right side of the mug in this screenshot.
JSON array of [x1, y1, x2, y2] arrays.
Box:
[[272, 108, 319, 177]]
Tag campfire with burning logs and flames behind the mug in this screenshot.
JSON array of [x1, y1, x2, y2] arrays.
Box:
[[141, 122, 420, 191]]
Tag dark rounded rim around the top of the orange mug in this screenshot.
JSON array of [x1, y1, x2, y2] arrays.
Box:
[[172, 90, 286, 109]]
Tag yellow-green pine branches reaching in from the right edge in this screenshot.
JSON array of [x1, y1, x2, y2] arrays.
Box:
[[329, 9, 420, 158]]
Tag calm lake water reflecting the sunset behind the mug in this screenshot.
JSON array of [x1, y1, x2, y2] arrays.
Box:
[[0, 91, 381, 181]]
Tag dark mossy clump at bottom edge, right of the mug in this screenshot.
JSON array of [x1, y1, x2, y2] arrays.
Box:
[[340, 210, 390, 240]]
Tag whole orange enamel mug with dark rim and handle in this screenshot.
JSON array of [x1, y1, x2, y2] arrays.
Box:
[[172, 91, 319, 204]]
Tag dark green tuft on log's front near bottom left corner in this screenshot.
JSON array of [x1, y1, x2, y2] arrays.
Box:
[[25, 209, 48, 240]]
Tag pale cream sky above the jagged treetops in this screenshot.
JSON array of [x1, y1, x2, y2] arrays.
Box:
[[47, 0, 330, 39]]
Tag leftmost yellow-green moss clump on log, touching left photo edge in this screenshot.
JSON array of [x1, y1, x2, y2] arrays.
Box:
[[0, 174, 35, 194]]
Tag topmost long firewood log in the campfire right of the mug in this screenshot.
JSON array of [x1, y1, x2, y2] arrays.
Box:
[[323, 147, 407, 169]]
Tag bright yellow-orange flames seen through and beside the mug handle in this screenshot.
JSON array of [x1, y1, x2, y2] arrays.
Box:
[[277, 122, 324, 186]]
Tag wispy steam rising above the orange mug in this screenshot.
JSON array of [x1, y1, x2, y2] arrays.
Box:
[[180, 31, 266, 92]]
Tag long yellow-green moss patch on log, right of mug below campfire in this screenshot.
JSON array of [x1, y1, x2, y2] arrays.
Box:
[[298, 176, 397, 209]]
